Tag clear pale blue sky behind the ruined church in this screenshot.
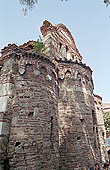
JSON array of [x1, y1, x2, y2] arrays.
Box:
[[0, 0, 110, 103]]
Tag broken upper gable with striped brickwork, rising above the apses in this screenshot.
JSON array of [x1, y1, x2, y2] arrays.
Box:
[[41, 21, 82, 61]]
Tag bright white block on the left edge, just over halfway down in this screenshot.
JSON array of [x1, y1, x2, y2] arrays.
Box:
[[0, 96, 8, 112]]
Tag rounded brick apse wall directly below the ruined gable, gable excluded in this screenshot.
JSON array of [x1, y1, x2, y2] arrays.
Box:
[[58, 62, 100, 169]]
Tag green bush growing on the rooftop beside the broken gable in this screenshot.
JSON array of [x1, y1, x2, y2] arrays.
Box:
[[33, 40, 46, 53]]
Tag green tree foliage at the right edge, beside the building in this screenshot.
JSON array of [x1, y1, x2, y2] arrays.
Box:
[[104, 112, 110, 133]]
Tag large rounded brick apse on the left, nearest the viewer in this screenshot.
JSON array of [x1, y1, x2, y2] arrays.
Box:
[[0, 44, 59, 170]]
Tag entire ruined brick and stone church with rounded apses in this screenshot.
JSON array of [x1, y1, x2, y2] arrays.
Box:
[[0, 21, 106, 170]]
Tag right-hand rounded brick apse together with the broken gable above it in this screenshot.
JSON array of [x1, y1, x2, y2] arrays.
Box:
[[41, 21, 105, 170]]
